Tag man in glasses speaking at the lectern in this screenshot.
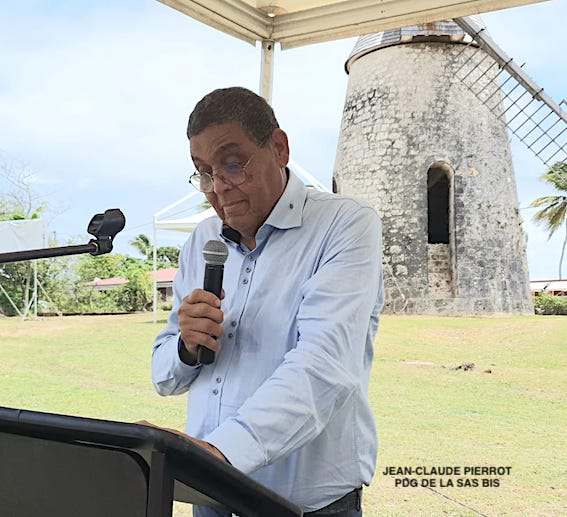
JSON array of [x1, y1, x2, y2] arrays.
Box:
[[152, 88, 383, 517]]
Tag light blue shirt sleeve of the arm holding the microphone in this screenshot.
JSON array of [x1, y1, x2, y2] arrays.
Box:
[[152, 237, 201, 396]]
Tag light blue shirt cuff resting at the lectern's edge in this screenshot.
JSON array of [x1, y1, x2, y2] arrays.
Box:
[[203, 418, 267, 474]]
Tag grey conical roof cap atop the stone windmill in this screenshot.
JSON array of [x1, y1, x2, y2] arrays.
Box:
[[345, 16, 484, 74]]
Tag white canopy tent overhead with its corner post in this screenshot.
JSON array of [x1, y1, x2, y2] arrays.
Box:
[[159, 0, 545, 102]]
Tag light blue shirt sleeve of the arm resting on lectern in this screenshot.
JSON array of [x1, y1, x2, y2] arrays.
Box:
[[204, 208, 383, 473]]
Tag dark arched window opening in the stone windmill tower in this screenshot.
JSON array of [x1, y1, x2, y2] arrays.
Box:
[[427, 163, 451, 244]]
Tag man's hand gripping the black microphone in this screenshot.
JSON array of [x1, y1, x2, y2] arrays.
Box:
[[177, 289, 224, 363]]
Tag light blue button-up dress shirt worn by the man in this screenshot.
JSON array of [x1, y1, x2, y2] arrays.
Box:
[[152, 173, 383, 511]]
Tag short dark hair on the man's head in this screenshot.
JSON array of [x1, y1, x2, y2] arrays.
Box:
[[187, 86, 280, 147]]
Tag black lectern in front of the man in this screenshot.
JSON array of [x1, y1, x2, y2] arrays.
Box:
[[0, 407, 302, 517]]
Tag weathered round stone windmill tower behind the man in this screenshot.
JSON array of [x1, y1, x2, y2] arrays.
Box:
[[333, 21, 533, 315]]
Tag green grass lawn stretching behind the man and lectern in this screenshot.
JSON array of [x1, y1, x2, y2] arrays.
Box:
[[0, 314, 567, 517]]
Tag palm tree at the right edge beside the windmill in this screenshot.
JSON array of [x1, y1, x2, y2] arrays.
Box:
[[530, 162, 567, 279]]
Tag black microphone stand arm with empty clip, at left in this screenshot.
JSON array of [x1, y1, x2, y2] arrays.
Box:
[[0, 208, 126, 264]]
